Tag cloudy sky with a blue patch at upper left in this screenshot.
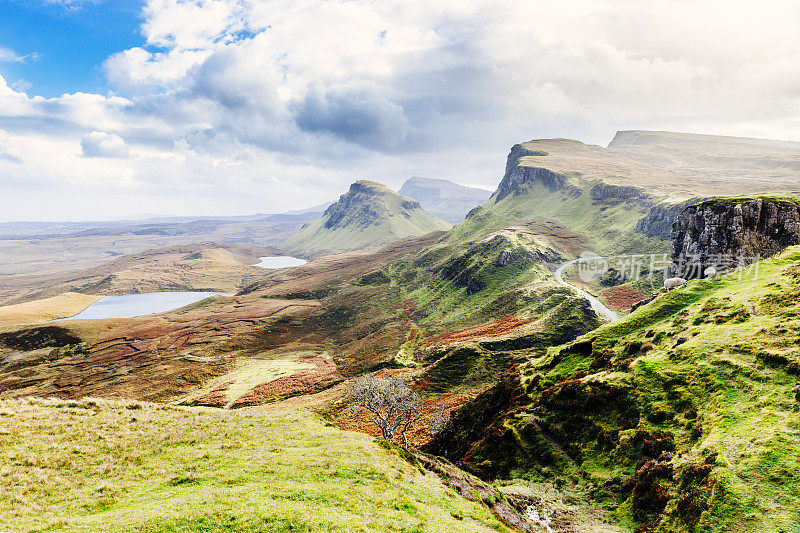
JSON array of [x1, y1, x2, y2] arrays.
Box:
[[0, 0, 800, 221]]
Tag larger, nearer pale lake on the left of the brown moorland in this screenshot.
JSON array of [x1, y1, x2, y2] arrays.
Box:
[[59, 292, 227, 320]]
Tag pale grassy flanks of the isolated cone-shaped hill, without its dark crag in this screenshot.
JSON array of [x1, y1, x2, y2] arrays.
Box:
[[283, 181, 452, 253]]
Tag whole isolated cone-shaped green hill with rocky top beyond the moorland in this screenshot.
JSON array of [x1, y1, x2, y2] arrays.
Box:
[[282, 180, 451, 254]]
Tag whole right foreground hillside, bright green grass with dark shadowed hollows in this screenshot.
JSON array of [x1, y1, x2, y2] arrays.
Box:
[[430, 247, 800, 532]]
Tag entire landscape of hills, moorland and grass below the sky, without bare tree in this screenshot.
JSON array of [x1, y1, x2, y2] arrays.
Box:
[[0, 131, 800, 533]]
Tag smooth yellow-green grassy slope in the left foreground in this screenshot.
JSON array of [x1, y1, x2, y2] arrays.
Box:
[[0, 400, 506, 532]]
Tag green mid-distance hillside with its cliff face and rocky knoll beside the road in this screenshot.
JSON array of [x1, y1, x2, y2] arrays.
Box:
[[382, 148, 682, 334]]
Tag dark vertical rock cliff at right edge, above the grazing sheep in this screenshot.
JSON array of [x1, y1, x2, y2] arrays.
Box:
[[671, 197, 800, 277]]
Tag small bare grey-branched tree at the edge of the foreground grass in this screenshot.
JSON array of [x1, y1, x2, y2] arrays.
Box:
[[347, 376, 424, 448]]
